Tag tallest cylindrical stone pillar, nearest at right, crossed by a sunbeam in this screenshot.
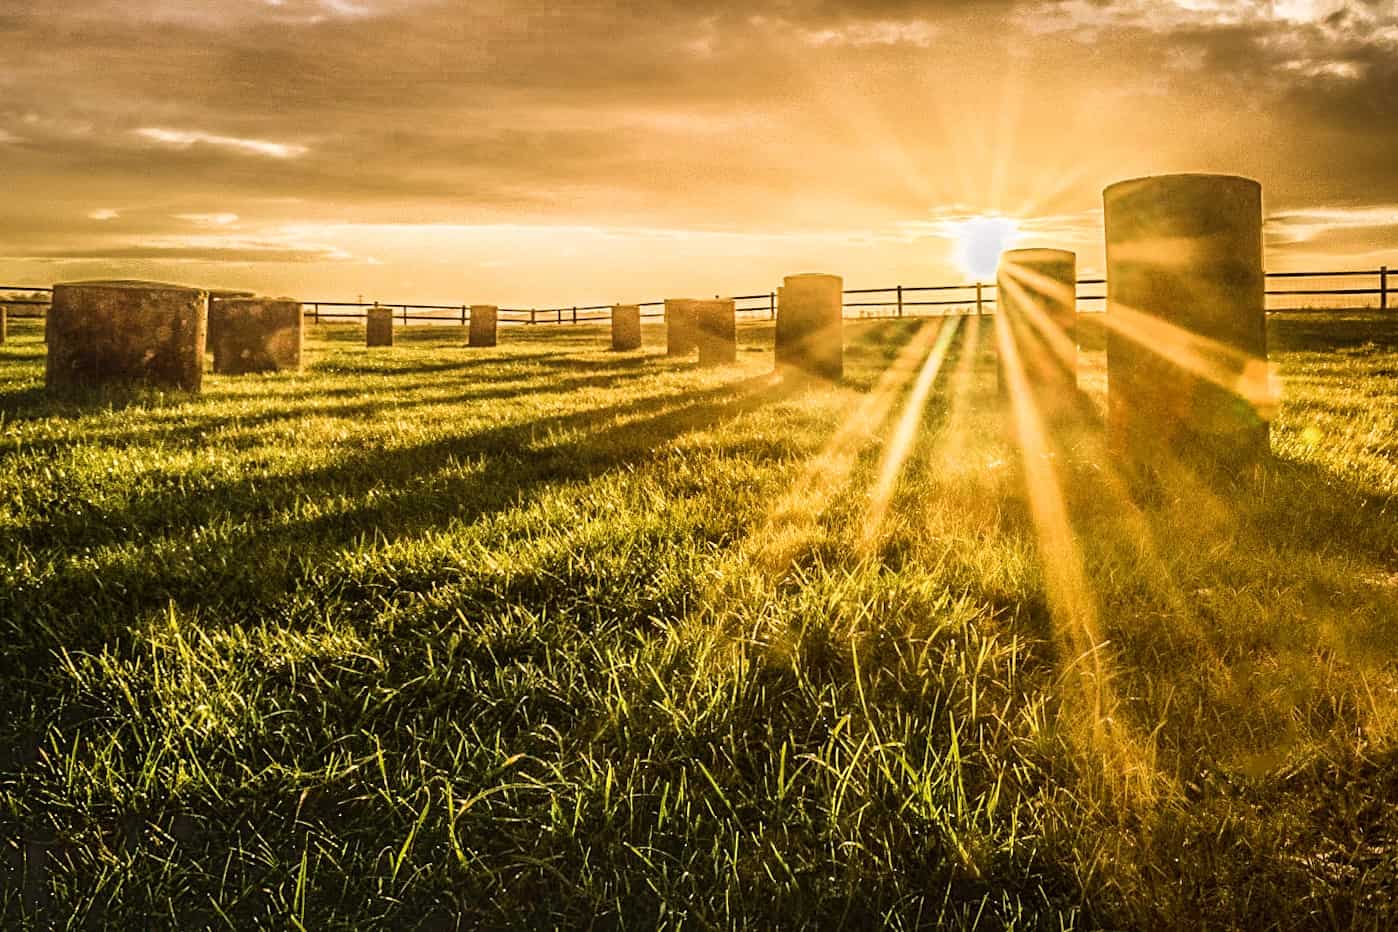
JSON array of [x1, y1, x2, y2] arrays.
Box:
[[1103, 175, 1271, 467]]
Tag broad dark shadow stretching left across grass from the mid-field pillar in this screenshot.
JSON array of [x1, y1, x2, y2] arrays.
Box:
[[0, 368, 781, 668]]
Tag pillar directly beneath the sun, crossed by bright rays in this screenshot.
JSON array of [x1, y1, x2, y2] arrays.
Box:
[[995, 249, 1078, 402]]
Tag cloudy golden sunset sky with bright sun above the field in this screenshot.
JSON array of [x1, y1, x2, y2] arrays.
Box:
[[0, 0, 1398, 307]]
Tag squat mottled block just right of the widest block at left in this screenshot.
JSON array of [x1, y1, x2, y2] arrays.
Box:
[[208, 298, 306, 376]]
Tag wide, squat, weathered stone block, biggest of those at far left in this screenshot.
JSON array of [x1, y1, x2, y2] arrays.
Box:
[[45, 281, 208, 391]]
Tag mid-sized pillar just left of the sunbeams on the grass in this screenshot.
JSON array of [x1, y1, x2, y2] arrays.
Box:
[[776, 274, 844, 381]]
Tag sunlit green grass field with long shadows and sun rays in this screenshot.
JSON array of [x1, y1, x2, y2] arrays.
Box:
[[0, 314, 1398, 929]]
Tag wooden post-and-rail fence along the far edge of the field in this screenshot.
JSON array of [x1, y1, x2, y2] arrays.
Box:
[[0, 265, 1394, 326]]
